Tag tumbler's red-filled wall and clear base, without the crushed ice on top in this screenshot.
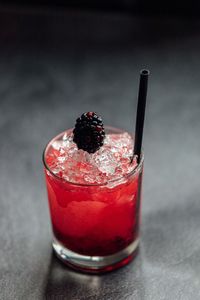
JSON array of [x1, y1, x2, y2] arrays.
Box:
[[43, 127, 144, 273]]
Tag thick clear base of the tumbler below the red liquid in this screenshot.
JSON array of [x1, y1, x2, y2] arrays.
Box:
[[53, 238, 139, 273]]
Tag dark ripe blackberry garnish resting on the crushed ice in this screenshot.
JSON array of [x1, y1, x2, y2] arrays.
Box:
[[73, 112, 105, 153]]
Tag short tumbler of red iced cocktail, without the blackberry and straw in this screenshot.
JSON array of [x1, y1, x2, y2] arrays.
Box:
[[44, 128, 143, 271]]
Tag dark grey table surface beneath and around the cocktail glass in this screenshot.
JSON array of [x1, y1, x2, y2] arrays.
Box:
[[0, 10, 200, 300]]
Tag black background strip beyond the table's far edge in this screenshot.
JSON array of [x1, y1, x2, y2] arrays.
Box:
[[0, 0, 200, 16]]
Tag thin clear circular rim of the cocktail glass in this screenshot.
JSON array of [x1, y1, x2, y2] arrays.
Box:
[[42, 126, 144, 187]]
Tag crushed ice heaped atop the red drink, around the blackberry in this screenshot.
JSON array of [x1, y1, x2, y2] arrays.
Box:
[[46, 131, 136, 184]]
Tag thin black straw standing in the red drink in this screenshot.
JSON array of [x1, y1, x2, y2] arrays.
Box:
[[134, 70, 150, 163]]
